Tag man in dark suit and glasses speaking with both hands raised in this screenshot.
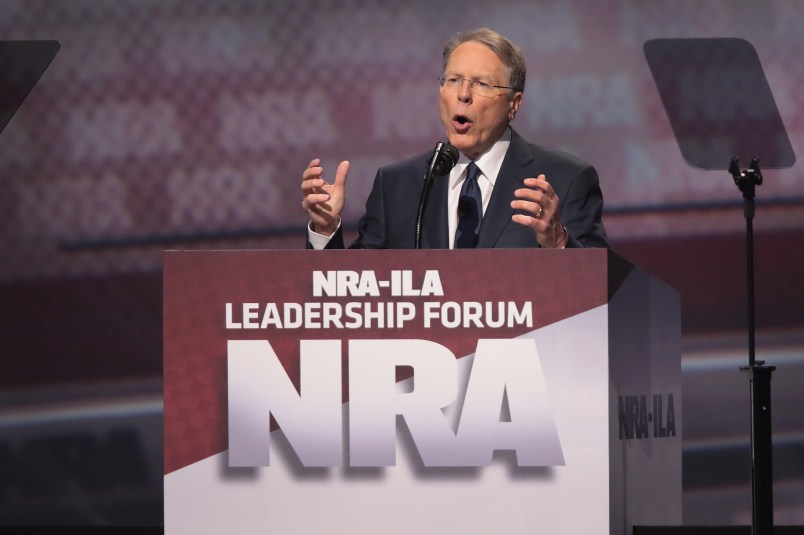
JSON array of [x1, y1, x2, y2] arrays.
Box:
[[302, 28, 608, 249]]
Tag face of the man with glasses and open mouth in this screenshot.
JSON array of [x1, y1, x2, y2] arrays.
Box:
[[439, 41, 522, 160]]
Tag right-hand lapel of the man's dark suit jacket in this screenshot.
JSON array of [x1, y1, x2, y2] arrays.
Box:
[[477, 129, 533, 248]]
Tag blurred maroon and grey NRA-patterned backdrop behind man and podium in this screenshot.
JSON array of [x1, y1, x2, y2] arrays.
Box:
[[0, 0, 804, 525]]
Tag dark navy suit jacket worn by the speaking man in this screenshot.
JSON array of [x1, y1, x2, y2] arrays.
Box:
[[318, 132, 608, 249]]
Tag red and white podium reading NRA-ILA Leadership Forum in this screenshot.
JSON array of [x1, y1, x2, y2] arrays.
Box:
[[164, 249, 681, 534]]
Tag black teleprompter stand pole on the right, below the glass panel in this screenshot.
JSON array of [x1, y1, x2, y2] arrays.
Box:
[[729, 158, 776, 535]]
